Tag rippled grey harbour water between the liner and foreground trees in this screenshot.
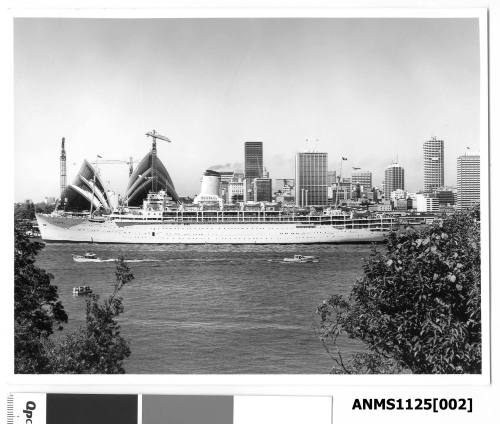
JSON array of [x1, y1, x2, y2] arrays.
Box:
[[38, 243, 370, 374]]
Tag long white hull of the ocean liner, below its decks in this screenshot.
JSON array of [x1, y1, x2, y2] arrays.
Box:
[[37, 215, 387, 244]]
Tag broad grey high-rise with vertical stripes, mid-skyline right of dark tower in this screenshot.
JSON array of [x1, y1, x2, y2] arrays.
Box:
[[295, 152, 328, 206]]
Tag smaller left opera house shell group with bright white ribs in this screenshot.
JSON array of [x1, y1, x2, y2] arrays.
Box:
[[61, 159, 112, 211]]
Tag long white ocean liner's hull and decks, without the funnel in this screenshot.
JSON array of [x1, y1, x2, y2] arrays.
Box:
[[36, 191, 430, 244]]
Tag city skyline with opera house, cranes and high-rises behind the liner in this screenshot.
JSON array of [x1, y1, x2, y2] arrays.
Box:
[[47, 131, 480, 210]]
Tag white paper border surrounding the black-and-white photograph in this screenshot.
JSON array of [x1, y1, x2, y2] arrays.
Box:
[[1, 8, 491, 394]]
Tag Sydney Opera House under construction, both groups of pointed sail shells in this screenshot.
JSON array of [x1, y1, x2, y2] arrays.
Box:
[[61, 143, 179, 212]]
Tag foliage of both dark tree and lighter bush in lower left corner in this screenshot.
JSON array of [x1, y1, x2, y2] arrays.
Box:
[[14, 221, 134, 374]]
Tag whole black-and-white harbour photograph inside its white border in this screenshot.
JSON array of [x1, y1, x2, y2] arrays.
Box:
[[13, 14, 490, 375]]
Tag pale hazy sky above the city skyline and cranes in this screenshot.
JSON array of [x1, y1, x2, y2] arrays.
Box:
[[14, 18, 479, 201]]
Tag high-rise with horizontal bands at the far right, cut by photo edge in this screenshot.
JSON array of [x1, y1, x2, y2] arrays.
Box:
[[457, 154, 481, 209]]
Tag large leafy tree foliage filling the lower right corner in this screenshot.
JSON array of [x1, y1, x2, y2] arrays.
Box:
[[317, 210, 481, 374]]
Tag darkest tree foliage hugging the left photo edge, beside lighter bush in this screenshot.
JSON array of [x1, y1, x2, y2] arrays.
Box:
[[14, 223, 68, 373]]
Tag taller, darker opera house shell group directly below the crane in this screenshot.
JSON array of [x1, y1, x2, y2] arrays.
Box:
[[125, 147, 179, 206]]
